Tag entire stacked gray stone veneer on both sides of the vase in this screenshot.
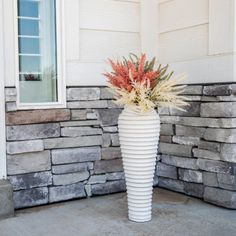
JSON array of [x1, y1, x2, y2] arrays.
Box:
[[6, 84, 236, 208]]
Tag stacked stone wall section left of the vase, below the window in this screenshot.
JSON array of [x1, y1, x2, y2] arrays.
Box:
[[6, 88, 128, 208]]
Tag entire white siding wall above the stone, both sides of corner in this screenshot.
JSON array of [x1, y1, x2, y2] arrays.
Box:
[[1, 0, 236, 86]]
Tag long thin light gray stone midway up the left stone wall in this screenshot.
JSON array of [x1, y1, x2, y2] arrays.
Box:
[[44, 135, 102, 149]]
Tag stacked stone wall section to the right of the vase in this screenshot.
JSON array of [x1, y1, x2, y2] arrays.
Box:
[[156, 84, 236, 209]]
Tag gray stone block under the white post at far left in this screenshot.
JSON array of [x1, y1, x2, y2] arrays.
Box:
[[0, 180, 14, 219]]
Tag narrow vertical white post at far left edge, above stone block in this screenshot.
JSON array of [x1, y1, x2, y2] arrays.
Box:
[[0, 1, 7, 179]]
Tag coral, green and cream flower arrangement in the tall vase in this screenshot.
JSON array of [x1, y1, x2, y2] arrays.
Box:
[[104, 54, 188, 112]]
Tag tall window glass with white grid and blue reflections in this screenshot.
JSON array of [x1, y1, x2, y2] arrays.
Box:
[[17, 0, 63, 105]]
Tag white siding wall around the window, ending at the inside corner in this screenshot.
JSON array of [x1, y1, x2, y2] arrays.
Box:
[[4, 0, 158, 86]]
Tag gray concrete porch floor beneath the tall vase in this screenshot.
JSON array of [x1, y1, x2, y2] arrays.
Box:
[[0, 188, 236, 236]]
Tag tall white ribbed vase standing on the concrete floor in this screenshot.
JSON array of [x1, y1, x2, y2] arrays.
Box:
[[118, 108, 160, 222]]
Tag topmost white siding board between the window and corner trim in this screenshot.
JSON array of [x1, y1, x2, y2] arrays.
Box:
[[80, 0, 140, 32]]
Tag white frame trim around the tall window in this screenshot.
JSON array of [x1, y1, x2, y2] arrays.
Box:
[[14, 0, 66, 110]]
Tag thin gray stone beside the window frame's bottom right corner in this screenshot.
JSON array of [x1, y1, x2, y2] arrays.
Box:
[[67, 100, 108, 109]]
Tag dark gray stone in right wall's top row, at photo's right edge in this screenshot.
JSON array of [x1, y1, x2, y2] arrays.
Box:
[[203, 84, 236, 96]]
